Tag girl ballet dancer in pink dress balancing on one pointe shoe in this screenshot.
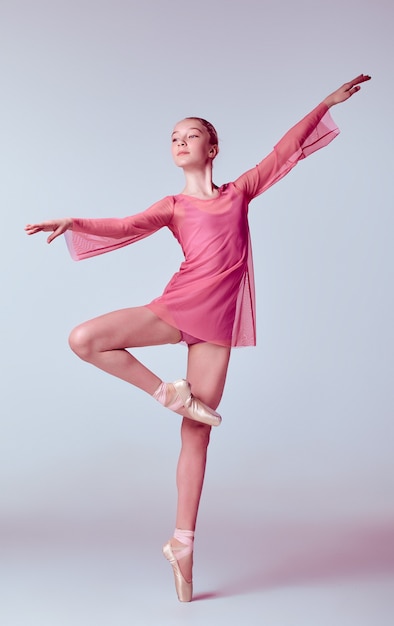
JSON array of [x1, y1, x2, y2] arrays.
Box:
[[25, 74, 370, 602]]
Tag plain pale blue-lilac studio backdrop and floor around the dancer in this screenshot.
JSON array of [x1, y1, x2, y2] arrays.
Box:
[[0, 0, 394, 626]]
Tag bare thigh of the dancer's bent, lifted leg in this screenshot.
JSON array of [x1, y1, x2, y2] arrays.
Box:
[[70, 306, 181, 352]]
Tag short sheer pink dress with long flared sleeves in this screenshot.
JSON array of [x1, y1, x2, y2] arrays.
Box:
[[66, 103, 339, 346]]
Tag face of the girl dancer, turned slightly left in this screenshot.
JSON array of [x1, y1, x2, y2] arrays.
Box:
[[171, 119, 217, 168]]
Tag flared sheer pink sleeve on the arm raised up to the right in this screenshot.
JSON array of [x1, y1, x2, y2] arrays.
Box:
[[234, 102, 339, 202]]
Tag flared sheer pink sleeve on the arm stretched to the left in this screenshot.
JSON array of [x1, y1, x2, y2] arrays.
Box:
[[65, 196, 174, 261]]
